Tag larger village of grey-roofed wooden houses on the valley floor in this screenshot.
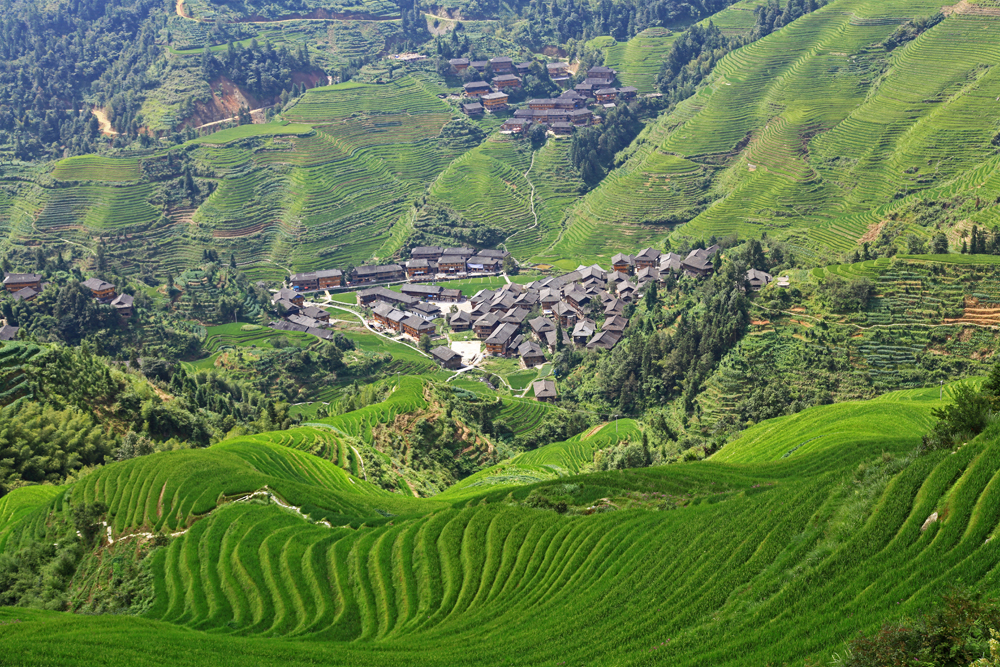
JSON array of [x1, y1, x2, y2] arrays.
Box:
[[262, 245, 773, 400]]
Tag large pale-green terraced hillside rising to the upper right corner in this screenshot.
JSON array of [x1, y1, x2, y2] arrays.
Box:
[[555, 0, 1000, 266]]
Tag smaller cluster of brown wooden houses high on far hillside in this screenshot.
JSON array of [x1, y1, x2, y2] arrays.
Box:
[[449, 57, 638, 136]]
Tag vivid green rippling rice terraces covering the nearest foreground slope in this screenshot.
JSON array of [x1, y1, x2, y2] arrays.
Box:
[[0, 380, 1000, 665]]
